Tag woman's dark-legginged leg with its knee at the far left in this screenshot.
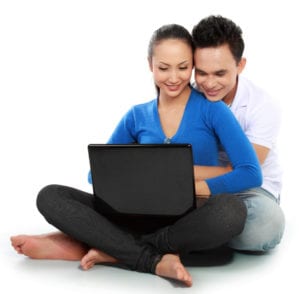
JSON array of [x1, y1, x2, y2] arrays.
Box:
[[37, 185, 161, 273]]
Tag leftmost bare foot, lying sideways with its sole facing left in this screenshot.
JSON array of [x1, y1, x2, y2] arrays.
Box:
[[10, 232, 88, 260]]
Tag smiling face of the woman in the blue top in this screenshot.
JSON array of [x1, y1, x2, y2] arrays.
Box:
[[149, 39, 193, 97]]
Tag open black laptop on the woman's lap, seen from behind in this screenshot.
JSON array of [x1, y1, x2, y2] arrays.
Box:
[[88, 144, 196, 221]]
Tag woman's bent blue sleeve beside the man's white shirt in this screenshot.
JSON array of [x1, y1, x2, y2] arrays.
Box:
[[206, 102, 262, 195]]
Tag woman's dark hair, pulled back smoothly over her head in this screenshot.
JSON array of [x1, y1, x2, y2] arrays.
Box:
[[148, 24, 194, 58]]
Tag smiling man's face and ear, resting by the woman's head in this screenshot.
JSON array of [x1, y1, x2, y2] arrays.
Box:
[[194, 45, 246, 103]]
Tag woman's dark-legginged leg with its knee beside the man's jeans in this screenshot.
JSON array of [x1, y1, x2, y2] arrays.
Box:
[[143, 195, 247, 253]]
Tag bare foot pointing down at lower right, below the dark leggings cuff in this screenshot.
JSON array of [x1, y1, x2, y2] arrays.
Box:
[[155, 254, 193, 287]]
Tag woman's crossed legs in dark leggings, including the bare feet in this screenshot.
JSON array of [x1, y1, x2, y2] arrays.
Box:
[[11, 185, 246, 286]]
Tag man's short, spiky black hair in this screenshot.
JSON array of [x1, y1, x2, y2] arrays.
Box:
[[192, 15, 245, 63]]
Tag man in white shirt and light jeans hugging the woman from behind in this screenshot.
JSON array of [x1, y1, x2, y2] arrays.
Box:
[[192, 16, 285, 251]]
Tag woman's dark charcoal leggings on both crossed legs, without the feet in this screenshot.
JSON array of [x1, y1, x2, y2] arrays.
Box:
[[37, 185, 247, 273]]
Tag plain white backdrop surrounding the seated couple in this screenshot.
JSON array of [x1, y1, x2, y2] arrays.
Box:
[[0, 0, 300, 293]]
